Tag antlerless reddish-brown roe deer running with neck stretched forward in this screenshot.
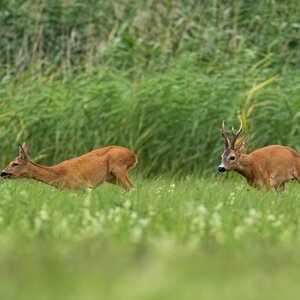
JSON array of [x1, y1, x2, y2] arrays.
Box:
[[1, 143, 138, 190]]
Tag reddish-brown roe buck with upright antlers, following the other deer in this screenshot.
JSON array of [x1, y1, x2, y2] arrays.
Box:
[[218, 121, 300, 191]]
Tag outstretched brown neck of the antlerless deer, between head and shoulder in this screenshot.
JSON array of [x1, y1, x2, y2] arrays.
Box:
[[26, 161, 60, 186]]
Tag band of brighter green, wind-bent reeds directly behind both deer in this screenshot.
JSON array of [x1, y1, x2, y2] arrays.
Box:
[[0, 56, 300, 175]]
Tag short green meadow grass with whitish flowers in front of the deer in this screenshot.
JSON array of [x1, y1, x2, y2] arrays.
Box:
[[0, 176, 300, 300]]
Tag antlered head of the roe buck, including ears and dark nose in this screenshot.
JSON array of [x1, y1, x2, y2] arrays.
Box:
[[218, 121, 250, 173]]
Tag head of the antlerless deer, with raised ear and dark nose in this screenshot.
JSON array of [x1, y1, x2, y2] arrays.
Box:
[[0, 143, 28, 179]]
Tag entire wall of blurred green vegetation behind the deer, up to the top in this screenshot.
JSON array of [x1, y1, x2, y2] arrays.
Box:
[[0, 0, 300, 176]]
